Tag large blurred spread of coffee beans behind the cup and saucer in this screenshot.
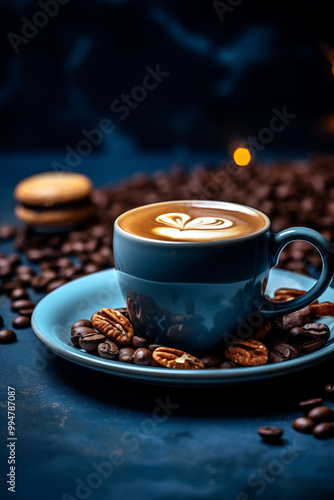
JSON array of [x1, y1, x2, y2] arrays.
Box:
[[0, 157, 334, 340]]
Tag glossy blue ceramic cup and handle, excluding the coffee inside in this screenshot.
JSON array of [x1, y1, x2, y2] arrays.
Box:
[[114, 200, 333, 352]]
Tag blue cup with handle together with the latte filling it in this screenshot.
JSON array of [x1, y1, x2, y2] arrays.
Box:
[[114, 200, 333, 352]]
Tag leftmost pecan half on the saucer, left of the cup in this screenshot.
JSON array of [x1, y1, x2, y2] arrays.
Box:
[[92, 308, 134, 347]]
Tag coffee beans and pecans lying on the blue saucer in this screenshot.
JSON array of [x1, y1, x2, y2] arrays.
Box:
[[71, 288, 334, 369]]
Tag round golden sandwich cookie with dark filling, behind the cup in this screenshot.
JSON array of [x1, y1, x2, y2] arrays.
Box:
[[14, 172, 93, 227]]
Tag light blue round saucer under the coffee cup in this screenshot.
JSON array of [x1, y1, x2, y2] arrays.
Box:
[[32, 269, 334, 385]]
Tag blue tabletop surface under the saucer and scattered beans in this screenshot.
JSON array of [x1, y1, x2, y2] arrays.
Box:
[[0, 155, 334, 500]]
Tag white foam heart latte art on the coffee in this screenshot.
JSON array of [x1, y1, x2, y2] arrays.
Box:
[[156, 212, 233, 231]]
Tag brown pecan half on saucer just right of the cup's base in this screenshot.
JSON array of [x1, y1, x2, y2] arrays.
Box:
[[224, 339, 269, 366]]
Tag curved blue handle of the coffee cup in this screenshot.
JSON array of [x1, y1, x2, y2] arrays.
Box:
[[260, 227, 334, 317]]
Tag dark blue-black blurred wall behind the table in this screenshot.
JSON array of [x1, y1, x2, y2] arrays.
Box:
[[0, 0, 334, 155]]
